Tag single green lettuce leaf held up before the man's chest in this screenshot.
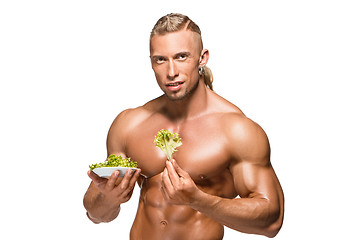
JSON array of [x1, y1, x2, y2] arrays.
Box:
[[154, 129, 182, 160]]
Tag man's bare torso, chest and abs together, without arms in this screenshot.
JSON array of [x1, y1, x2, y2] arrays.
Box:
[[118, 93, 242, 240]]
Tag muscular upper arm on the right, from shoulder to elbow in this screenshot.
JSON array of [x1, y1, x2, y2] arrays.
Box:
[[230, 117, 283, 209]]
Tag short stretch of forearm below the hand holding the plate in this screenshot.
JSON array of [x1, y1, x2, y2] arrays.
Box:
[[84, 190, 120, 223]]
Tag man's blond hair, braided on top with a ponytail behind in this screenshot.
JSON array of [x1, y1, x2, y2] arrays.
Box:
[[150, 13, 213, 90]]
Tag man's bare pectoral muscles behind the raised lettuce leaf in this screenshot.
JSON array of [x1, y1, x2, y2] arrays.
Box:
[[126, 115, 229, 183]]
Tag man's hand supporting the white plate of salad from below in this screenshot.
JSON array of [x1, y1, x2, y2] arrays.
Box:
[[88, 169, 141, 206]]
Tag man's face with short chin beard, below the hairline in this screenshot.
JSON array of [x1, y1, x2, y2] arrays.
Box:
[[150, 30, 205, 100]]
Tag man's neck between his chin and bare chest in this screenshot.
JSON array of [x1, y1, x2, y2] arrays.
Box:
[[164, 78, 208, 121]]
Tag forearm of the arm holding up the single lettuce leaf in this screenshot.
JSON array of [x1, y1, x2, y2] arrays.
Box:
[[191, 192, 280, 237]]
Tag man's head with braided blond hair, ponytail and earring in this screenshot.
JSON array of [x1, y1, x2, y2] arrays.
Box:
[[150, 14, 212, 100]]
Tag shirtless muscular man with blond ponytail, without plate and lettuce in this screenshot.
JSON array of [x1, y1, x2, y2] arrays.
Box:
[[84, 14, 284, 240]]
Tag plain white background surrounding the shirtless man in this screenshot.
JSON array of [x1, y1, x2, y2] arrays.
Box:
[[0, 0, 360, 240]]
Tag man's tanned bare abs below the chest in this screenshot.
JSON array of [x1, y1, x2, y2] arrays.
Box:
[[130, 174, 224, 240]]
